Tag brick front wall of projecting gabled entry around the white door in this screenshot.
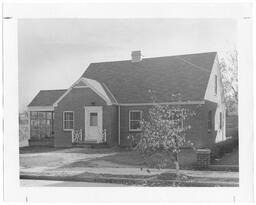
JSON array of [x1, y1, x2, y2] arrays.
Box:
[[54, 88, 117, 147]]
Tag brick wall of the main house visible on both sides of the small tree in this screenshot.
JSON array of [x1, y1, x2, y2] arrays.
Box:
[[120, 101, 217, 148]]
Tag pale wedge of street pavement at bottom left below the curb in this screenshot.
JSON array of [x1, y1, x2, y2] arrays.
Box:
[[20, 179, 127, 187]]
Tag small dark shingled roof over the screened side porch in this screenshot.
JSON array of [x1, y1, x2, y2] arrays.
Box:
[[28, 90, 67, 107]]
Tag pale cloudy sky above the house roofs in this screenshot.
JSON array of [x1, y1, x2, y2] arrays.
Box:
[[18, 19, 237, 112]]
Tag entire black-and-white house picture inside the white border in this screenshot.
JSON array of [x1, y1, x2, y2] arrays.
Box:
[[18, 18, 239, 187]]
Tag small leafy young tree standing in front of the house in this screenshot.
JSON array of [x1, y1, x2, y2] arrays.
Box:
[[135, 94, 195, 177]]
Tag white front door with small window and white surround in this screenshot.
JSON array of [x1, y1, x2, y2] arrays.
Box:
[[85, 106, 103, 143]]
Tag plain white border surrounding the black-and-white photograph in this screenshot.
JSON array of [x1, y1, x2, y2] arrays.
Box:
[[2, 3, 253, 202]]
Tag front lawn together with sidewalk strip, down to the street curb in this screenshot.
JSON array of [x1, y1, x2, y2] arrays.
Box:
[[20, 147, 238, 186]]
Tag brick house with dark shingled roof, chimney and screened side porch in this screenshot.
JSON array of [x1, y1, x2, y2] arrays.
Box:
[[28, 51, 226, 147]]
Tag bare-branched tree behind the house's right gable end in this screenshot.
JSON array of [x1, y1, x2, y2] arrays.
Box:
[[220, 50, 238, 113]]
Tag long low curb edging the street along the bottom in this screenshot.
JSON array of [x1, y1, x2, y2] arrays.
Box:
[[20, 175, 239, 187]]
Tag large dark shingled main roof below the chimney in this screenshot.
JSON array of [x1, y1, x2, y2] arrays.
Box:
[[82, 52, 217, 103]]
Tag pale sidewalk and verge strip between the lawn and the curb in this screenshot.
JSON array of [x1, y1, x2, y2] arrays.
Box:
[[20, 167, 239, 186]]
